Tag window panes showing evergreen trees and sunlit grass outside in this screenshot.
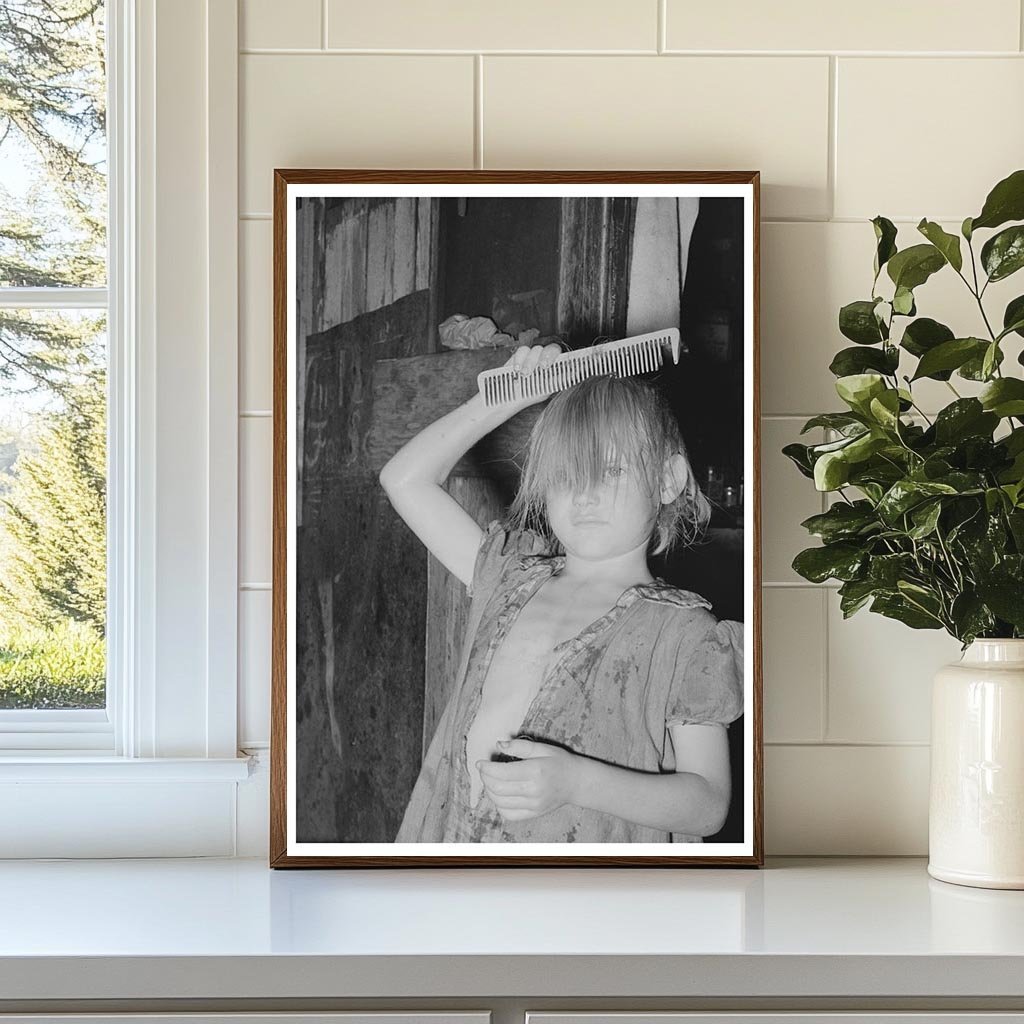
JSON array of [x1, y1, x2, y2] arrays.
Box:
[[0, 0, 114, 751]]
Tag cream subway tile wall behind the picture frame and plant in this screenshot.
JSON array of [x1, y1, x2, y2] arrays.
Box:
[[239, 0, 1024, 854]]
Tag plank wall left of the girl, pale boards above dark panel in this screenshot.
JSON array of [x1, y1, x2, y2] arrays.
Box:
[[295, 198, 437, 843]]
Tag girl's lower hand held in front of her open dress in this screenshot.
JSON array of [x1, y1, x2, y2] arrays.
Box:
[[476, 741, 581, 821]]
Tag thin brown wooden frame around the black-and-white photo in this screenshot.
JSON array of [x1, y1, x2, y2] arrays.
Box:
[[269, 168, 764, 868]]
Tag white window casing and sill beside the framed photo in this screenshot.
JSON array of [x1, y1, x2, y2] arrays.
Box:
[[0, 0, 249, 856]]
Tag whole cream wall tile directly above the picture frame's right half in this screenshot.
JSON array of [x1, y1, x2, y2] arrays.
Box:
[[481, 56, 829, 217]]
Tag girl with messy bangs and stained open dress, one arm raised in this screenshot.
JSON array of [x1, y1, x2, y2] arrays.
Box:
[[380, 345, 743, 843]]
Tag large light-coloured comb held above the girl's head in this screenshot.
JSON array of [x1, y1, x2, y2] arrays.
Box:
[[476, 327, 679, 406]]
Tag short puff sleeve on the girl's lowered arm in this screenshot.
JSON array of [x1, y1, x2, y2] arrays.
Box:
[[665, 620, 743, 726]]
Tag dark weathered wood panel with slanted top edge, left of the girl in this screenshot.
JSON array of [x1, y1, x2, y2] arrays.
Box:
[[296, 282, 429, 843]]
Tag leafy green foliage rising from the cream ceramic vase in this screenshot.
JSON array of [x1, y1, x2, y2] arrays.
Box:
[[782, 170, 1024, 646]]
